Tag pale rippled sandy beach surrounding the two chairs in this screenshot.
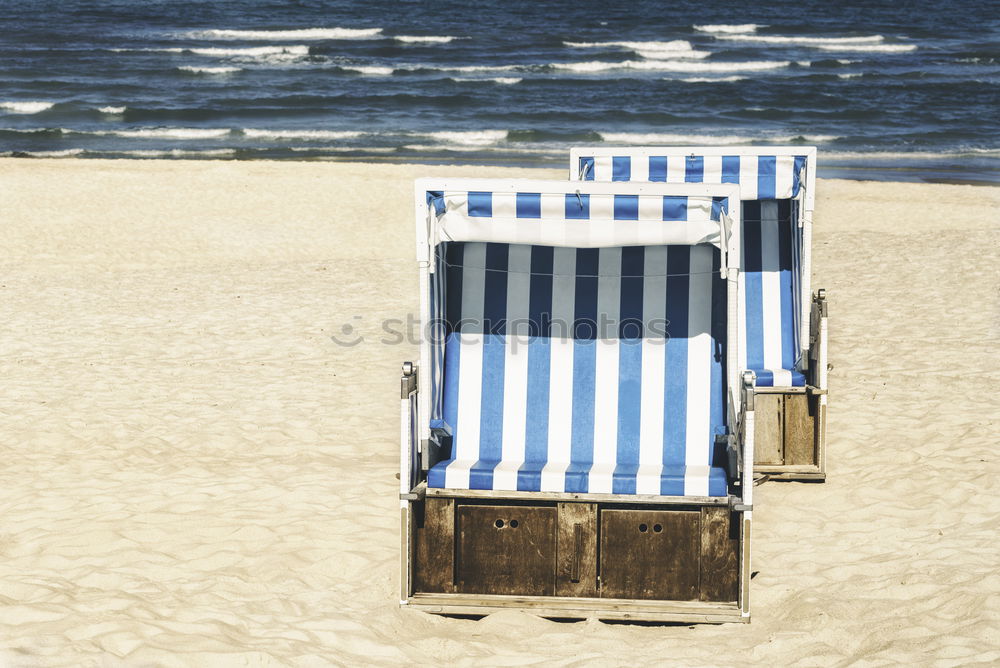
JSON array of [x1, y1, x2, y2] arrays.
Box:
[[0, 155, 1000, 667]]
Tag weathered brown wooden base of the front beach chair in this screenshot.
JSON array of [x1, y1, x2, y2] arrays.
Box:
[[405, 494, 749, 622]]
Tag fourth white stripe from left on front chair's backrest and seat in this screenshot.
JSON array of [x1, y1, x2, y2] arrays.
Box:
[[588, 248, 622, 494]]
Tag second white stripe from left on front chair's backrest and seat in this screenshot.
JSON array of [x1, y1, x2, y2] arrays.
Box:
[[493, 244, 531, 490]]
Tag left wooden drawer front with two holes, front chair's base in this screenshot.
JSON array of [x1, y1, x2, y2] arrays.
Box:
[[455, 505, 557, 596]]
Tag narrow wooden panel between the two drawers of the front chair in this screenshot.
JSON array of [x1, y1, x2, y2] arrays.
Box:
[[556, 503, 597, 596]]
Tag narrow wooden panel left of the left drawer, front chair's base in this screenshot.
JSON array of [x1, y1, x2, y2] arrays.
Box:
[[413, 498, 455, 593]]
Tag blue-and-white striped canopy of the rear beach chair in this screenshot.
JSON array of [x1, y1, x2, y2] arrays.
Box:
[[576, 149, 807, 200]]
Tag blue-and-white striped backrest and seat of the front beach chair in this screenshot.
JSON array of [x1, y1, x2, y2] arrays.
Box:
[[428, 242, 727, 496]]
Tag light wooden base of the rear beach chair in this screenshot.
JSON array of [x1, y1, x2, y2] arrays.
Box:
[[754, 388, 826, 481]]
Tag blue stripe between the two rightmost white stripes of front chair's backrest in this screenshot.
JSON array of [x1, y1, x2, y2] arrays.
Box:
[[663, 246, 691, 470]]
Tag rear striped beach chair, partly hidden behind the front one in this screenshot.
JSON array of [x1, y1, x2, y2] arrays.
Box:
[[570, 146, 827, 481]]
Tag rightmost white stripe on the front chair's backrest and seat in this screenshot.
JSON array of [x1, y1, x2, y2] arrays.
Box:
[[684, 246, 712, 495]]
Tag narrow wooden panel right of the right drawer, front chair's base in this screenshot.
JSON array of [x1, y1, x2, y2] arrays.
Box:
[[699, 508, 740, 602]]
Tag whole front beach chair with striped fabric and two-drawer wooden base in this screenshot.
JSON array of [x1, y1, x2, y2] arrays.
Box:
[[400, 179, 754, 622]]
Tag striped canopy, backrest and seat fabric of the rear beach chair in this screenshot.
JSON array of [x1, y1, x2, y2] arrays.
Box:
[[571, 148, 812, 386]]
